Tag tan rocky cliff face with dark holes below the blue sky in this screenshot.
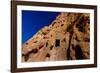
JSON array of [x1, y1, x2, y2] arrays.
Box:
[[22, 13, 90, 62]]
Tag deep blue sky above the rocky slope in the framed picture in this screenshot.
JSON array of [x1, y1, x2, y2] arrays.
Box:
[[22, 10, 60, 43]]
